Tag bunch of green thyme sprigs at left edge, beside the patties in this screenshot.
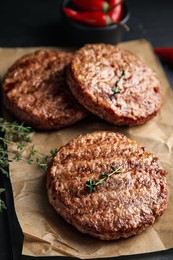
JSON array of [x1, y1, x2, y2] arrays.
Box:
[[0, 118, 57, 212]]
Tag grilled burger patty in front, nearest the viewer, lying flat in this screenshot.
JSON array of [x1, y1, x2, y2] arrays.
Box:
[[47, 131, 167, 240]]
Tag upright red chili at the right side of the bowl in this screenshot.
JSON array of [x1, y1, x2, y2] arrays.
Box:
[[108, 0, 123, 23]]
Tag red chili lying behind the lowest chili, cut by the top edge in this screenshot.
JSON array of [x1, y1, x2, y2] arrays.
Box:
[[71, 0, 109, 13]]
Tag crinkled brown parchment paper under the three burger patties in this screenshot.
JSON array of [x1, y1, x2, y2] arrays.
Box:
[[0, 40, 173, 258]]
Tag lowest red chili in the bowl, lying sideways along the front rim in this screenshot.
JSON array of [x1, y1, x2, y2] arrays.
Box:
[[64, 7, 112, 26]]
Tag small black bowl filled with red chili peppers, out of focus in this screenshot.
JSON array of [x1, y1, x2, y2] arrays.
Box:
[[62, 0, 130, 46]]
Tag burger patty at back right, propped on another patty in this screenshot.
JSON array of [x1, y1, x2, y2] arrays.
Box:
[[67, 44, 161, 126]]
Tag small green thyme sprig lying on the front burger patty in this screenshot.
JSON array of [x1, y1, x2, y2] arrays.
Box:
[[85, 166, 120, 193]]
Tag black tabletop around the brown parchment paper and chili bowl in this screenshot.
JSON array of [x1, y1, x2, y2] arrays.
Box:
[[0, 0, 173, 260]]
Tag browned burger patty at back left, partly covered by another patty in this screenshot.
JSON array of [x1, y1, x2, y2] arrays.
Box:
[[3, 49, 88, 129]]
